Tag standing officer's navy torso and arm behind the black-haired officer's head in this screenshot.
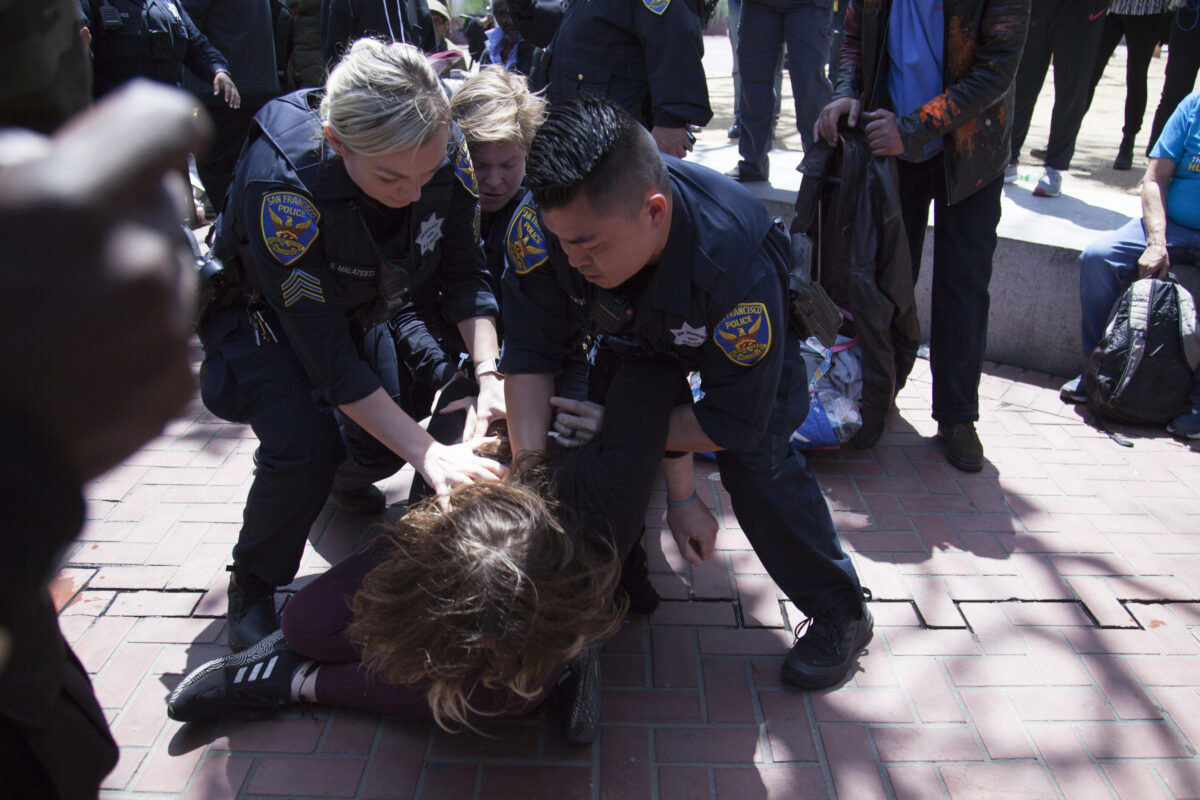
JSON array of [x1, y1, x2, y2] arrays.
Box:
[[510, 0, 713, 158]]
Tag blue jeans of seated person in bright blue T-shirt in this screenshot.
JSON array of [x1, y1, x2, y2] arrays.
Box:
[[1079, 214, 1200, 359]]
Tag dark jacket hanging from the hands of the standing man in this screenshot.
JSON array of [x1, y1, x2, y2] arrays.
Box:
[[792, 124, 920, 423]]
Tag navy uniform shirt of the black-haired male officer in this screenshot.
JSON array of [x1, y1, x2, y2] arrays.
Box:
[[503, 157, 808, 450]]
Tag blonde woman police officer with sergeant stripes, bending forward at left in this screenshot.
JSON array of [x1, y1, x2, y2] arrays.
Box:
[[200, 40, 503, 649]]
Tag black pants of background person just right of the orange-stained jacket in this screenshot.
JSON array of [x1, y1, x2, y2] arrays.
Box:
[[1013, 0, 1109, 169]]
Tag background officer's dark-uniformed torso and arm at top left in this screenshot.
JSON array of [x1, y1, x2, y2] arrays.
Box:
[[80, 0, 240, 108]]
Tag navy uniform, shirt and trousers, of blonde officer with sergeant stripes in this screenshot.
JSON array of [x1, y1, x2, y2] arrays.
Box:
[[200, 90, 498, 585]]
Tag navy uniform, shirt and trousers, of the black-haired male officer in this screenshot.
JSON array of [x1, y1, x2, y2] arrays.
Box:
[[502, 157, 862, 615]]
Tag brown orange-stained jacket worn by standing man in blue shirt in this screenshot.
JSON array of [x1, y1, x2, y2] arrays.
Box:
[[833, 0, 1030, 204]]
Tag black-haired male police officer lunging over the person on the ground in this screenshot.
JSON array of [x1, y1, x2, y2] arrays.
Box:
[[503, 95, 872, 688]]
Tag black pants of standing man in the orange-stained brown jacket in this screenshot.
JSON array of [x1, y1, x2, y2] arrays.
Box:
[[896, 154, 1004, 422]]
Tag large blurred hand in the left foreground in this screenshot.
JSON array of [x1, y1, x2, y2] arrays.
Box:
[[0, 80, 210, 480]]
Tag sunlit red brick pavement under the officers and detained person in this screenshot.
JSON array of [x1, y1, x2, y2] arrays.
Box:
[[65, 347, 1200, 800]]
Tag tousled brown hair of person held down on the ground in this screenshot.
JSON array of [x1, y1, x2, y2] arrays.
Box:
[[348, 481, 626, 729]]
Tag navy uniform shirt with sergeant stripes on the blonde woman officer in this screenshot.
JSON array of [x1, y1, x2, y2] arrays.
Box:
[[218, 90, 498, 407]]
